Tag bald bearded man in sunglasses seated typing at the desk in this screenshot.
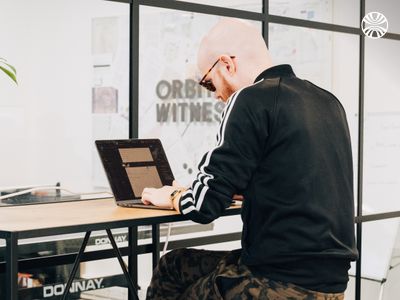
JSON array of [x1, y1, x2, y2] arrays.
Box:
[[142, 19, 358, 300]]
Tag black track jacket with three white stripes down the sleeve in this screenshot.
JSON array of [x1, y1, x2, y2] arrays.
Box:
[[180, 65, 358, 292]]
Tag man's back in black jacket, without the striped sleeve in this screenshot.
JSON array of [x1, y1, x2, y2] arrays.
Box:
[[237, 65, 357, 292]]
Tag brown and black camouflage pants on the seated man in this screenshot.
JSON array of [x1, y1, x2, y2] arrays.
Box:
[[146, 249, 344, 300]]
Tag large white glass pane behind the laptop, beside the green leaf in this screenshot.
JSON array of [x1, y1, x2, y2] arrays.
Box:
[[0, 0, 129, 196]]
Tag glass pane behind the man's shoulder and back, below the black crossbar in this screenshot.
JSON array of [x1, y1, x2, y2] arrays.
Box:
[[269, 24, 359, 209]]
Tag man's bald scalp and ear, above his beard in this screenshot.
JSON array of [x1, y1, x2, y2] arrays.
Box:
[[197, 18, 272, 101]]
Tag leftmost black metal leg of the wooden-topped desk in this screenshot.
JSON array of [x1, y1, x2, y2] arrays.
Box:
[[5, 233, 18, 300]]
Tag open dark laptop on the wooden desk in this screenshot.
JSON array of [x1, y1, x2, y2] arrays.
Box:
[[95, 139, 174, 210]]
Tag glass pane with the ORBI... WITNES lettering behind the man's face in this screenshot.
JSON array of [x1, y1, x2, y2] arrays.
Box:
[[139, 6, 261, 184]]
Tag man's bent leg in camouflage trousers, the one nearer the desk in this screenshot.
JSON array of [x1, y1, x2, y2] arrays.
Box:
[[146, 249, 229, 300]]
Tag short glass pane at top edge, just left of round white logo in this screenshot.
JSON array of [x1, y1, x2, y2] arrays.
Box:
[[269, 0, 360, 27]]
